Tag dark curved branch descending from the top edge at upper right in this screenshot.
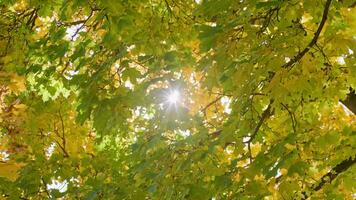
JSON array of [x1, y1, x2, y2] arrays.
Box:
[[282, 0, 332, 68]]
